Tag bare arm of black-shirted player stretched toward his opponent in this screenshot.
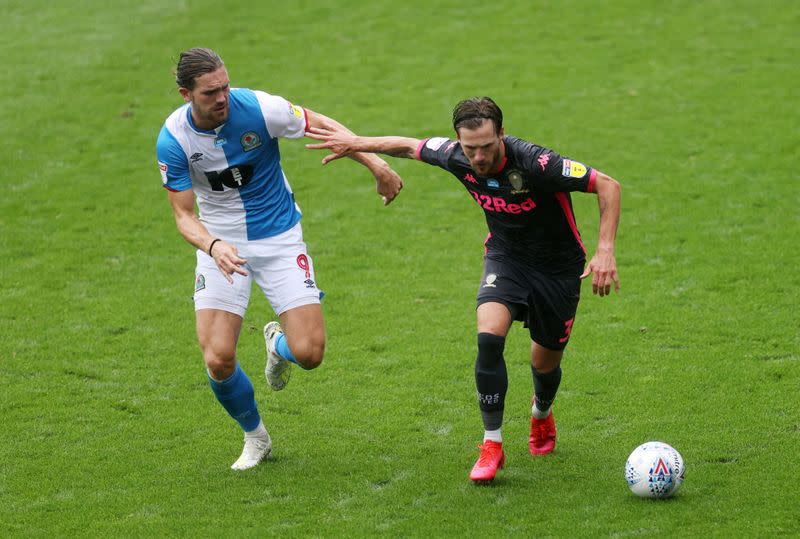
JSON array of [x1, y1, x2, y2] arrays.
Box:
[[306, 127, 421, 165]]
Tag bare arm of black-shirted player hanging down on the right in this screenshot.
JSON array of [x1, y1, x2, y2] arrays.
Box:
[[581, 171, 620, 296]]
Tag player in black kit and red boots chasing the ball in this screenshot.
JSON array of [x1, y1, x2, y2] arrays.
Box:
[[307, 97, 620, 482]]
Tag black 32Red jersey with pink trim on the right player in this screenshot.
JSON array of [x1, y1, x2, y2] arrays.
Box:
[[417, 136, 597, 273]]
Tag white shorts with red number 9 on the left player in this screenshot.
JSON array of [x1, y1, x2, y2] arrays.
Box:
[[194, 223, 320, 318]]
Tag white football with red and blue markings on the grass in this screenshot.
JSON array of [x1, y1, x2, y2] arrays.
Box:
[[625, 442, 685, 498]]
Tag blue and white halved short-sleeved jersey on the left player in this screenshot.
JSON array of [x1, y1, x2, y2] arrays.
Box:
[[156, 88, 308, 241]]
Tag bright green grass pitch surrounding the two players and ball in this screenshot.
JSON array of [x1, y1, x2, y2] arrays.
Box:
[[0, 0, 800, 536]]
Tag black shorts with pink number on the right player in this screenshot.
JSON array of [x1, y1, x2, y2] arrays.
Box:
[[478, 256, 581, 350]]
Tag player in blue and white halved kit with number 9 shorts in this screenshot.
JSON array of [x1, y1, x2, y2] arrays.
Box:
[[156, 48, 402, 470]]
